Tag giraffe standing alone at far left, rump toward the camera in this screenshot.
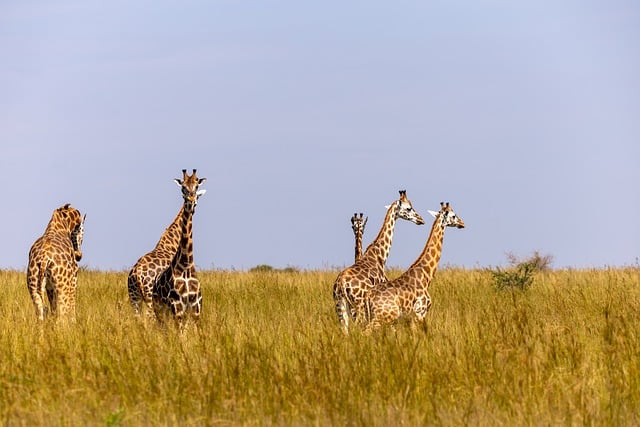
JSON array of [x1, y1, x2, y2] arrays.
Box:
[[27, 203, 84, 320]]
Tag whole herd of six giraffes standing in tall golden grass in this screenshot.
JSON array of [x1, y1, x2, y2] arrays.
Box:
[[27, 169, 465, 333]]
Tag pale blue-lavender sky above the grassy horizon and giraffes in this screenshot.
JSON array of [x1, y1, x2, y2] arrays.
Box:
[[0, 0, 640, 270]]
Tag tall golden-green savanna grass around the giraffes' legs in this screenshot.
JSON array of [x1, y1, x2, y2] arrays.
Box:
[[0, 267, 640, 426]]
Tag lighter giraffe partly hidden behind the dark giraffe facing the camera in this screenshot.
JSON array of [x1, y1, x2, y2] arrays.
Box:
[[127, 207, 184, 318]]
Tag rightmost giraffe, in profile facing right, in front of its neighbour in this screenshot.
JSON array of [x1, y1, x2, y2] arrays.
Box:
[[365, 202, 464, 332]]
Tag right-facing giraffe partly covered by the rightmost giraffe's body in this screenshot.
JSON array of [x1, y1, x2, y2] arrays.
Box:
[[333, 190, 424, 333]]
